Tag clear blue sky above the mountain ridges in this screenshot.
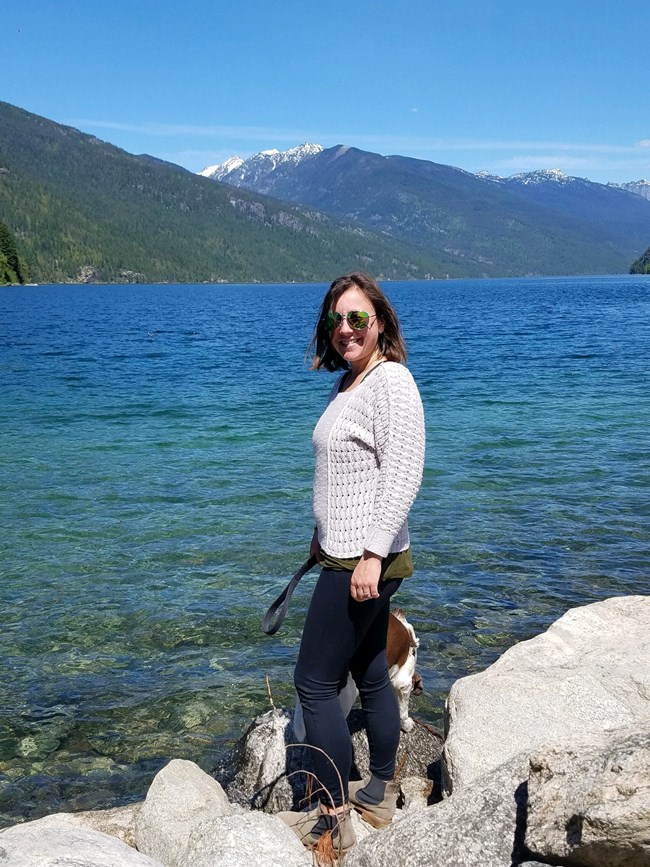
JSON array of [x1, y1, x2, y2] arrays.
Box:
[[5, 0, 650, 182]]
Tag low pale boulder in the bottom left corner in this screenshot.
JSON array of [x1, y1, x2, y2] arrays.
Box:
[[0, 814, 162, 867]]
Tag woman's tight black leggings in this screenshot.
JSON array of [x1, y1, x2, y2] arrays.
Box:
[[294, 569, 402, 806]]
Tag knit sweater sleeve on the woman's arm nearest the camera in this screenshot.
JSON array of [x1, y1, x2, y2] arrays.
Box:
[[364, 363, 425, 557]]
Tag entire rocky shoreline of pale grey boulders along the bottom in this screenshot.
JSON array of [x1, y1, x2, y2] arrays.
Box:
[[0, 596, 650, 867]]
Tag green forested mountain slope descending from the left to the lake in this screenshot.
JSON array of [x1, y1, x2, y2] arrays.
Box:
[[0, 102, 445, 282]]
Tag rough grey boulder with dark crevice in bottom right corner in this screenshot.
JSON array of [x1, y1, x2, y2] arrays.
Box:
[[526, 729, 650, 867]]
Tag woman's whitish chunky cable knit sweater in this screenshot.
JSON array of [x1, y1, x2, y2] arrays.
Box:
[[313, 361, 424, 558]]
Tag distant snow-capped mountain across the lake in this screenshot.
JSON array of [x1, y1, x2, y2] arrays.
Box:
[[205, 145, 650, 276]]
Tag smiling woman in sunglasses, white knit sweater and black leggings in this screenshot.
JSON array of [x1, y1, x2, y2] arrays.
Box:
[[280, 273, 424, 851]]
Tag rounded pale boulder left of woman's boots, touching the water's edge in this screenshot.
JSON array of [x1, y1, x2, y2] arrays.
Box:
[[135, 759, 232, 867]]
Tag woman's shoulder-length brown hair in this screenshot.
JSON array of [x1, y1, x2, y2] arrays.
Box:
[[307, 271, 406, 370]]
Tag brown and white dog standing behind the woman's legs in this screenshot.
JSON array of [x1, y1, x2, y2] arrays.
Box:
[[293, 608, 423, 743]]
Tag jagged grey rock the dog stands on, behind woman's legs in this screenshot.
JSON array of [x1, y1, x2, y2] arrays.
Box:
[[218, 709, 442, 813]]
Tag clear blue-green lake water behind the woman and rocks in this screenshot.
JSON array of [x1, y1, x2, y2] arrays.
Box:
[[0, 276, 650, 824]]
